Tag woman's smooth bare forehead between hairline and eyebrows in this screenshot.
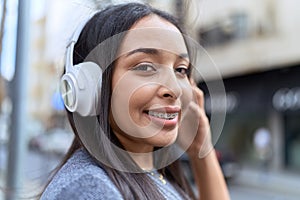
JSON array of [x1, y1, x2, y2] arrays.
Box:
[[119, 15, 187, 55]]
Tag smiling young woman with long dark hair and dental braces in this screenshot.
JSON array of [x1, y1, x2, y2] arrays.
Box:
[[41, 3, 229, 200]]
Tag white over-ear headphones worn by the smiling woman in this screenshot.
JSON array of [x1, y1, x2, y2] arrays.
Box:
[[60, 18, 102, 116]]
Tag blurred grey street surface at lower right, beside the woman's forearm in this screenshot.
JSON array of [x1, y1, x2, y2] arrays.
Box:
[[228, 170, 300, 200]]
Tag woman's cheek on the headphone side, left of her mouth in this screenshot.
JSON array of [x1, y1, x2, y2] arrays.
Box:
[[111, 83, 166, 138]]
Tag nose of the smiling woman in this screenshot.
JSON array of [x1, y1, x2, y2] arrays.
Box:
[[158, 70, 182, 99]]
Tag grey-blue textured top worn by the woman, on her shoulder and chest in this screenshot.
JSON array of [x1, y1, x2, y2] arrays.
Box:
[[41, 150, 186, 200]]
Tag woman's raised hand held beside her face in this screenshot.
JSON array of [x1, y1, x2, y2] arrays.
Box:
[[178, 80, 213, 158]]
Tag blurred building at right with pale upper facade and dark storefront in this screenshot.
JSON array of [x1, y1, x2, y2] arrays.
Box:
[[185, 0, 300, 171]]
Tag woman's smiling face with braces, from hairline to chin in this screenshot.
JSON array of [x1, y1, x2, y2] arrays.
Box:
[[110, 15, 192, 153]]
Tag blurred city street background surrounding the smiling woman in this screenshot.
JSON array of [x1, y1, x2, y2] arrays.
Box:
[[0, 0, 300, 200]]
